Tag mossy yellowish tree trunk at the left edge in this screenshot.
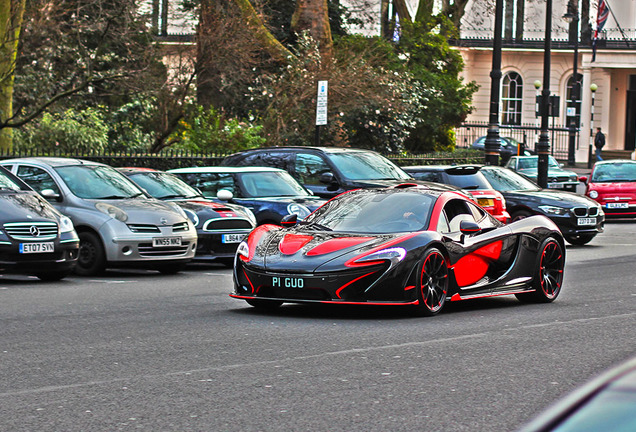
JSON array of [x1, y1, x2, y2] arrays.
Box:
[[0, 0, 26, 151]]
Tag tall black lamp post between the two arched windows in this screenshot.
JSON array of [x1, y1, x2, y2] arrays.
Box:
[[537, 0, 552, 188]]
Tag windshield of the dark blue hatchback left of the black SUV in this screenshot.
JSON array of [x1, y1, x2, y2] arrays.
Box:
[[239, 171, 310, 198]]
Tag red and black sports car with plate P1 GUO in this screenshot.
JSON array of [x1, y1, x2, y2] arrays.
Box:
[[230, 185, 565, 316]]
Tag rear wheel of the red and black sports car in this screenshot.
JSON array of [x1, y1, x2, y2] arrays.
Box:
[[515, 237, 565, 303]]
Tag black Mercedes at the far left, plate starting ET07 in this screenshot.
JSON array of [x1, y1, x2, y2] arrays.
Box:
[[0, 167, 79, 281]]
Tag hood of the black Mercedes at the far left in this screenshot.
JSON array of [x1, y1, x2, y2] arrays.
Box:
[[0, 191, 60, 222]]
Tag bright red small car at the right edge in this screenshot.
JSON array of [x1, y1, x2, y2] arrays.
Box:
[[581, 160, 636, 218]]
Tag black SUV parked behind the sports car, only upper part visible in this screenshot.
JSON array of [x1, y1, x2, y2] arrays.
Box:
[[221, 147, 414, 198]]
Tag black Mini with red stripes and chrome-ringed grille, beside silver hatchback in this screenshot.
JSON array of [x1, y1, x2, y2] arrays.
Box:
[[118, 168, 256, 265]]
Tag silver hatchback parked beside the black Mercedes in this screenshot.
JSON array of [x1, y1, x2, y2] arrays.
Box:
[[0, 157, 197, 276]]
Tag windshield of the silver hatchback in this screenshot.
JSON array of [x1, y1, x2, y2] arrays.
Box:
[[55, 165, 143, 199]]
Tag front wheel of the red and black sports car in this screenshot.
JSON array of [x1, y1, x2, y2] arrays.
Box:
[[416, 248, 449, 316]]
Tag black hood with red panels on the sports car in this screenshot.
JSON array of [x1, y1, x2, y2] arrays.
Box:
[[248, 225, 404, 273]]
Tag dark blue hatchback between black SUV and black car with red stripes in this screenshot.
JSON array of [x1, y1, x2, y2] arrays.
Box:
[[169, 167, 325, 225]]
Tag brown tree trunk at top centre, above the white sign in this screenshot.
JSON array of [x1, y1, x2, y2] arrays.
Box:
[[292, 0, 333, 63]]
